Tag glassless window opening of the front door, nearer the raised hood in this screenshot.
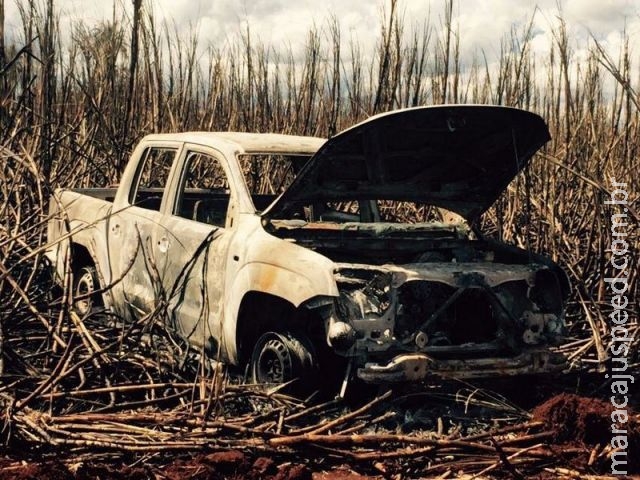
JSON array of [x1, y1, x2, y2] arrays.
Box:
[[175, 152, 230, 228]]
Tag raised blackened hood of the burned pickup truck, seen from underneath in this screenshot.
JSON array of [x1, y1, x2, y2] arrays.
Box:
[[264, 105, 550, 221]]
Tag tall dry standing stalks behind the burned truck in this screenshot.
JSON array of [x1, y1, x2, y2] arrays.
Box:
[[0, 0, 640, 378]]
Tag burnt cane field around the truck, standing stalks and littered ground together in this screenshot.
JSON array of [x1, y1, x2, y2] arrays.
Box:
[[0, 0, 640, 479]]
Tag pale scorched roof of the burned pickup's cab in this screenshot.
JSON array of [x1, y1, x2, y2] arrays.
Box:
[[144, 132, 326, 154]]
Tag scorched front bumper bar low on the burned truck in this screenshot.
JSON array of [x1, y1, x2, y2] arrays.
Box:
[[358, 350, 566, 383]]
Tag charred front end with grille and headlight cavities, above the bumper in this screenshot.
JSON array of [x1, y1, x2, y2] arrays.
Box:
[[328, 262, 564, 366]]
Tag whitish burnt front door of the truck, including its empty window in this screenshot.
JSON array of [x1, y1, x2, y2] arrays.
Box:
[[154, 148, 232, 354]]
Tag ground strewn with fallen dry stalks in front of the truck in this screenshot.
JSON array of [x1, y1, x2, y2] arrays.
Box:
[[0, 313, 640, 479]]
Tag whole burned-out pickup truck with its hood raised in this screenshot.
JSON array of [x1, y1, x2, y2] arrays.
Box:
[[48, 105, 569, 390]]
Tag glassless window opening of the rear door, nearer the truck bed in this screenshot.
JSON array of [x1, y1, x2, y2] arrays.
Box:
[[129, 147, 178, 211]]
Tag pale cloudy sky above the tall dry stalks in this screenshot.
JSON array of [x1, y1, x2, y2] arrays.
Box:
[[5, 0, 640, 72]]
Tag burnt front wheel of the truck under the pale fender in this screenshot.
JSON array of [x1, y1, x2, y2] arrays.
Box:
[[251, 332, 317, 392]]
